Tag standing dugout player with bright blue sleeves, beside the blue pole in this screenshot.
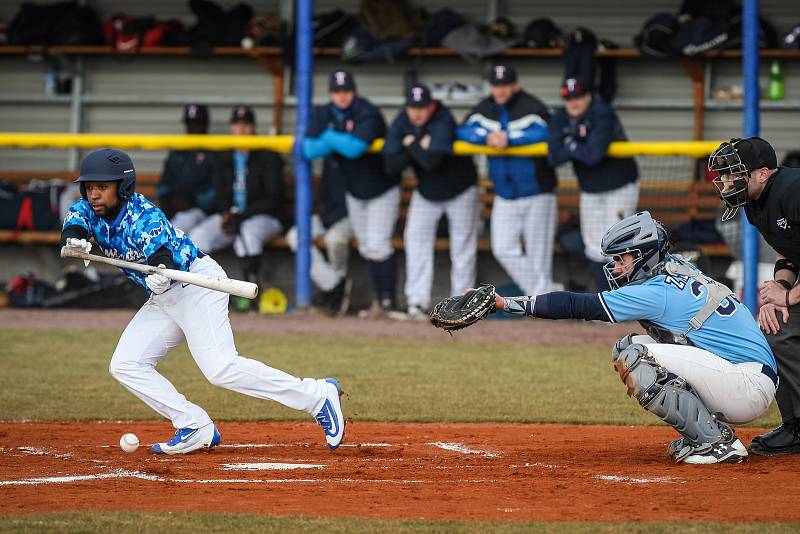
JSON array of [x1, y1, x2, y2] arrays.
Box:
[[303, 70, 400, 317]]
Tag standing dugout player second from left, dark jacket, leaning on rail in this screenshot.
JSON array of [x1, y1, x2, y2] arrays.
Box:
[[383, 84, 479, 320]]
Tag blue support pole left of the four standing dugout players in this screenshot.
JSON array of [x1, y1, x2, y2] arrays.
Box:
[[292, 0, 314, 307]]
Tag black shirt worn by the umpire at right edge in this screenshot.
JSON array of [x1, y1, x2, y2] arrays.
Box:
[[744, 167, 800, 264]]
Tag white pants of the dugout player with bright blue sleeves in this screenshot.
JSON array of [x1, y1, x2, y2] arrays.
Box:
[[346, 185, 400, 262]]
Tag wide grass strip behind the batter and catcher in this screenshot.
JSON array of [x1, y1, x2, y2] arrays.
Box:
[[0, 330, 780, 427]]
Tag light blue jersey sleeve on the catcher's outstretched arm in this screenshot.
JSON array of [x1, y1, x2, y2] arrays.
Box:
[[600, 278, 667, 323]]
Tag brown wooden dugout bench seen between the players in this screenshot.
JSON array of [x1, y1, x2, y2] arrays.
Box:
[[0, 171, 730, 256]]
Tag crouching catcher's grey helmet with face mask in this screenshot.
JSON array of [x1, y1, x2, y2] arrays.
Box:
[[600, 211, 669, 289]]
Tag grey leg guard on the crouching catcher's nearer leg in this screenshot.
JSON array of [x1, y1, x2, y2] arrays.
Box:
[[614, 346, 733, 462]]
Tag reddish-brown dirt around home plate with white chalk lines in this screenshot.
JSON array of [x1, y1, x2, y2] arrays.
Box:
[[0, 422, 800, 522]]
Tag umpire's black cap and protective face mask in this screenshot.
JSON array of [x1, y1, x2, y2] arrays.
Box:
[[708, 137, 778, 222]]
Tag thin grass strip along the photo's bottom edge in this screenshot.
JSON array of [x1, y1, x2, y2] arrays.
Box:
[[0, 512, 800, 534]]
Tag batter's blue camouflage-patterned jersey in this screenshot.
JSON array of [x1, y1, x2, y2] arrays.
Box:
[[64, 193, 198, 292]]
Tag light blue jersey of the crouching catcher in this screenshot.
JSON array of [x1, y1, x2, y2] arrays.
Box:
[[600, 264, 777, 372]]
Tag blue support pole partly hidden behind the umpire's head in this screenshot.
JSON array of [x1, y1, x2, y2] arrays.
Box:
[[742, 0, 761, 315]]
